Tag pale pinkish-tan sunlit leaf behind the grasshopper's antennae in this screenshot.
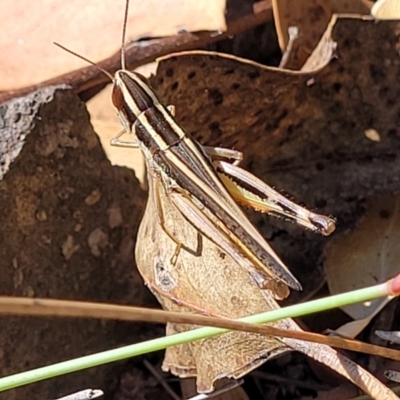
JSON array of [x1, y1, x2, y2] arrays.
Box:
[[0, 0, 226, 90]]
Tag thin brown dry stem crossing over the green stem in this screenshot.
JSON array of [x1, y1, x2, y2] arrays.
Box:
[[0, 296, 400, 361]]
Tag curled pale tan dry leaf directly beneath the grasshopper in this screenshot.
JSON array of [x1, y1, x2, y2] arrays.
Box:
[[135, 152, 398, 400]]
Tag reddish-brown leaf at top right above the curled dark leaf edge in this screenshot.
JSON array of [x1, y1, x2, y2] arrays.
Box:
[[272, 0, 369, 70]]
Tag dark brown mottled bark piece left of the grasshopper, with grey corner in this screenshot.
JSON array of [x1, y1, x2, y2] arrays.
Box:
[[0, 87, 154, 400]]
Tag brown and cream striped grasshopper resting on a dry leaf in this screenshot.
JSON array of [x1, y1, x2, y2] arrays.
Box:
[[57, 0, 335, 291]]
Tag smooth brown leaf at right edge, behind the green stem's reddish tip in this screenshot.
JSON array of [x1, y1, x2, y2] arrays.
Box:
[[324, 196, 400, 319]]
